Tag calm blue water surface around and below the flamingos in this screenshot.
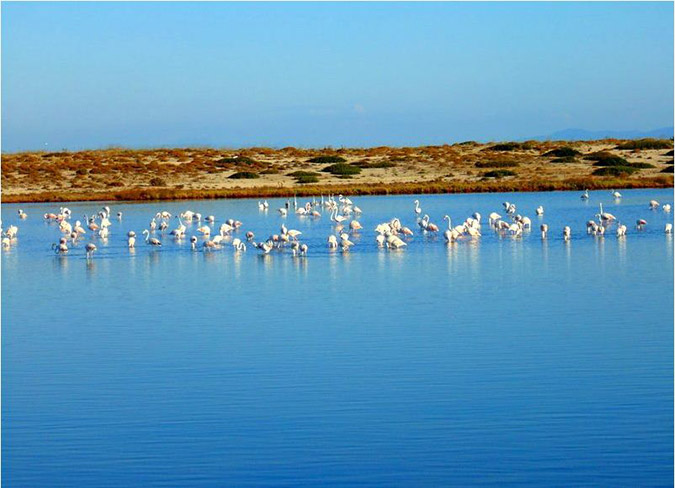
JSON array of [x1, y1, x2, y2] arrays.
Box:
[[0, 190, 673, 487]]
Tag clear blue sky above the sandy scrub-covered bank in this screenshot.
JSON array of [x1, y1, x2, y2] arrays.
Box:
[[2, 2, 673, 151]]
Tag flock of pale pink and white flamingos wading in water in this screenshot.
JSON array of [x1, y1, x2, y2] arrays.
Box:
[[0, 191, 673, 259]]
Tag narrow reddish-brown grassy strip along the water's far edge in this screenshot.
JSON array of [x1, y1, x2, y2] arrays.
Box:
[[0, 176, 673, 204]]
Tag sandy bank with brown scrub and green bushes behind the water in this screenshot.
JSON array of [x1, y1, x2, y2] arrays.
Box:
[[2, 139, 673, 203]]
